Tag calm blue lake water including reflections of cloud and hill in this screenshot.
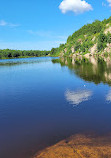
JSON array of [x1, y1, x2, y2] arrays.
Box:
[[0, 57, 111, 158]]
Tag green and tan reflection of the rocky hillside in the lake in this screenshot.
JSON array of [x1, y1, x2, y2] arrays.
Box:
[[52, 56, 111, 85]]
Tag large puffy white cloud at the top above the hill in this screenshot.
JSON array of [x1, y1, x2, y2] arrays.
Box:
[[59, 0, 93, 14]]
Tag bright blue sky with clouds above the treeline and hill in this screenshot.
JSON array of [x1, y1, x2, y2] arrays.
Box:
[[0, 0, 111, 50]]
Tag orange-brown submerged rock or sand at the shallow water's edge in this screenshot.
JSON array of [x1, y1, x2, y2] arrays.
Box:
[[34, 135, 111, 158]]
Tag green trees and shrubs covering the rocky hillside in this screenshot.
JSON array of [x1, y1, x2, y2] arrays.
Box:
[[58, 17, 111, 56]]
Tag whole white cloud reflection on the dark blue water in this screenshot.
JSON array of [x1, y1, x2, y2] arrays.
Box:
[[65, 90, 92, 106]]
